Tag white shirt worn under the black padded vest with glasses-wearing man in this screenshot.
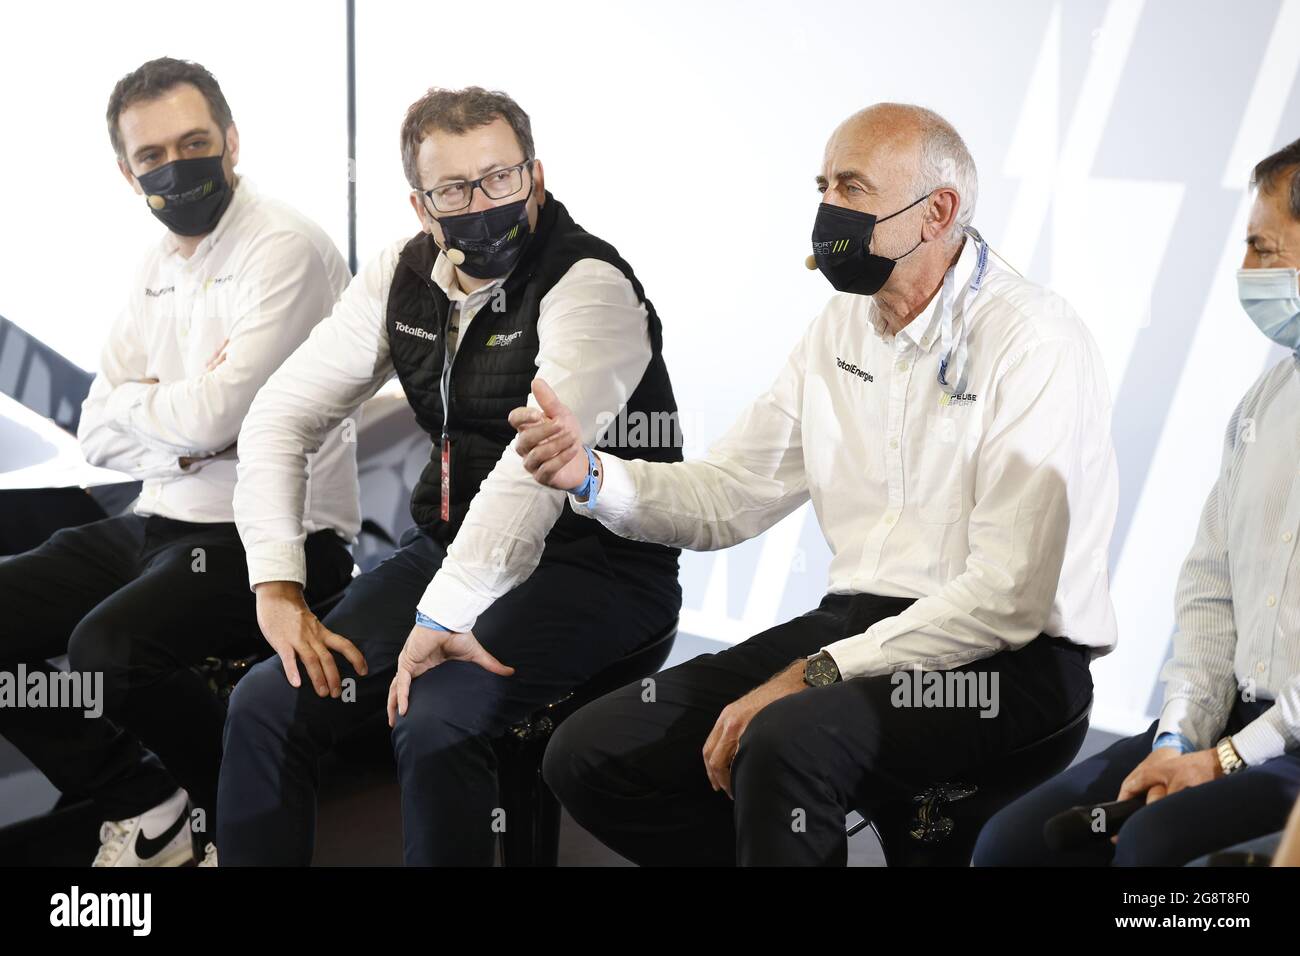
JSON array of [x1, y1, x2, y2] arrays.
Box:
[[235, 228, 651, 631]]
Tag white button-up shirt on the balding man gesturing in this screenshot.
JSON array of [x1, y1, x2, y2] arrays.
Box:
[[573, 242, 1118, 679]]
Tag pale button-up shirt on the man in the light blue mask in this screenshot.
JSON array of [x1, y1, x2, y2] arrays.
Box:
[[1157, 356, 1300, 766]]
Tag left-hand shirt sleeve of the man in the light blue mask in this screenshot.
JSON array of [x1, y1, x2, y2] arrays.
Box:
[[1156, 405, 1244, 760]]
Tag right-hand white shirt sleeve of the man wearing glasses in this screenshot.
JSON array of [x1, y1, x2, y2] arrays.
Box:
[[412, 259, 653, 632]]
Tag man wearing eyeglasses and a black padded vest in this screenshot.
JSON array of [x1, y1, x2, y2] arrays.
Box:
[[217, 87, 681, 865]]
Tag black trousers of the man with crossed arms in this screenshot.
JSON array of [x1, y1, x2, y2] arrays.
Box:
[[0, 514, 352, 827]]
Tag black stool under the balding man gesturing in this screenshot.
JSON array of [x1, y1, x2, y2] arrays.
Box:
[[848, 701, 1092, 866]]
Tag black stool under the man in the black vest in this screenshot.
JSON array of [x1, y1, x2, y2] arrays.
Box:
[[493, 622, 677, 866]]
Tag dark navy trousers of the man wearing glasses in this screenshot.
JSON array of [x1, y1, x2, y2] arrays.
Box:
[[217, 528, 681, 866]]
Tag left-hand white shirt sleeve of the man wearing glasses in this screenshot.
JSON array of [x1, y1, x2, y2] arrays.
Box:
[[234, 247, 397, 585]]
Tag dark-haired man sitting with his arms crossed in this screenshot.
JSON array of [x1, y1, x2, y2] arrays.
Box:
[[0, 57, 360, 866]]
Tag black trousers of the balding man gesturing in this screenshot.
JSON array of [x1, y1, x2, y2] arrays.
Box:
[[543, 594, 1092, 866]]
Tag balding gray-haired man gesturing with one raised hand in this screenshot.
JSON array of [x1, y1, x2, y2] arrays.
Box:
[[511, 104, 1117, 865]]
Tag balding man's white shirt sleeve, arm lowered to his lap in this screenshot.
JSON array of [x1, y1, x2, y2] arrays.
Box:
[[826, 338, 1109, 680]]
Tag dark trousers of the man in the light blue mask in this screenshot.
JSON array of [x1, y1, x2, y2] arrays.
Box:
[[974, 700, 1300, 866]]
